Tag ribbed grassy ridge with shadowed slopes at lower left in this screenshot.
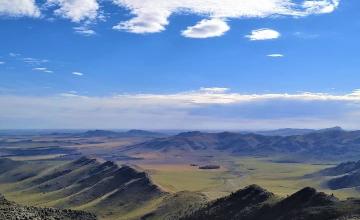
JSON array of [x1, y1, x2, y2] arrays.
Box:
[[0, 157, 167, 217]]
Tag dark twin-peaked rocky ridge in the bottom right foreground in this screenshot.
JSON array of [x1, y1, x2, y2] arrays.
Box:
[[182, 185, 360, 220]]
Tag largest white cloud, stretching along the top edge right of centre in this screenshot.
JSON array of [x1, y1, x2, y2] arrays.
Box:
[[113, 0, 339, 33]]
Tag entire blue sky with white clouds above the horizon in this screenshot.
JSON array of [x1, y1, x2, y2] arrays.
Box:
[[0, 0, 360, 130]]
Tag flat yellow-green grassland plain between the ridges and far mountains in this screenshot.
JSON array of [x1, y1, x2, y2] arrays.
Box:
[[139, 157, 358, 199]]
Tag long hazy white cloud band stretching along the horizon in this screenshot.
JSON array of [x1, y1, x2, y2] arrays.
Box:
[[0, 87, 360, 130]]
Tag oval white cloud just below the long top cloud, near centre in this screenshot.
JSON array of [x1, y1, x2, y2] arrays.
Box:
[[182, 18, 230, 38]]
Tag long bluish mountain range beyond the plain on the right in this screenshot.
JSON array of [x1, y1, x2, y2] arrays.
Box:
[[125, 127, 360, 160]]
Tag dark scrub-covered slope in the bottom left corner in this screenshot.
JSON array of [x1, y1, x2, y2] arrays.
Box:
[[0, 195, 97, 220]]
